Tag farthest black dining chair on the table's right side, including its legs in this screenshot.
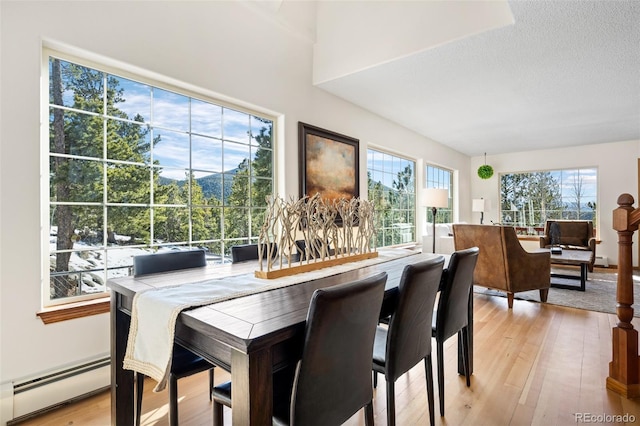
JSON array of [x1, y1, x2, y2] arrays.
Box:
[[431, 247, 480, 416]]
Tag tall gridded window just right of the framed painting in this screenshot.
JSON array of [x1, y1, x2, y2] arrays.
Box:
[[367, 149, 416, 247]]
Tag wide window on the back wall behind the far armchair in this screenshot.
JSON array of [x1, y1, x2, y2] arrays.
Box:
[[500, 167, 598, 235]]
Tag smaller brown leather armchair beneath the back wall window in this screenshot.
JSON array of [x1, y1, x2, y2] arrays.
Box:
[[540, 220, 596, 272]]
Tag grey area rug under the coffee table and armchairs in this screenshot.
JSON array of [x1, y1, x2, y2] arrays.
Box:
[[474, 268, 640, 317]]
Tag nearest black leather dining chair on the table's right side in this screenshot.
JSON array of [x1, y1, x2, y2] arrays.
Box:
[[213, 272, 387, 426]]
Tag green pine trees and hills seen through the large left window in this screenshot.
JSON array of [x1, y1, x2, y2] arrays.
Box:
[[49, 58, 273, 298]]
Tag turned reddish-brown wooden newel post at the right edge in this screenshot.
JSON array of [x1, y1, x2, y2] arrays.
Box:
[[607, 194, 640, 398]]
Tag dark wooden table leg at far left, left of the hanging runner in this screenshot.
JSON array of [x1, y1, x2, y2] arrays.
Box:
[[111, 291, 135, 426]]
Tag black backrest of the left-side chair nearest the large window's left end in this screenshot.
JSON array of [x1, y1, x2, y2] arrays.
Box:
[[133, 249, 207, 276]]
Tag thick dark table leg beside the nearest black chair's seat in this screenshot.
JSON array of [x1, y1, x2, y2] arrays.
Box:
[[231, 348, 273, 426]]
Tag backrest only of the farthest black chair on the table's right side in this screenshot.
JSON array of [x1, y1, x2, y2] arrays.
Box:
[[434, 247, 479, 341]]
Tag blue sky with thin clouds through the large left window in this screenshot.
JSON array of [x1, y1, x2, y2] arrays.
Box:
[[52, 61, 265, 179]]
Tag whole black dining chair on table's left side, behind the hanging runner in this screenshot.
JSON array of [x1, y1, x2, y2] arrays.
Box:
[[133, 250, 214, 426]]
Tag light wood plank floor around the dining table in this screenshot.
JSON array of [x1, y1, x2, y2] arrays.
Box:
[[15, 295, 640, 426]]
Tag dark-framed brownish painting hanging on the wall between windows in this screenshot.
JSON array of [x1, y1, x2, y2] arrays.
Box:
[[298, 122, 360, 201]]
